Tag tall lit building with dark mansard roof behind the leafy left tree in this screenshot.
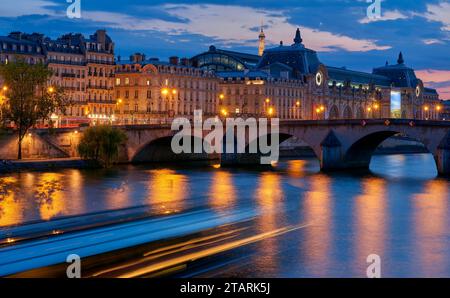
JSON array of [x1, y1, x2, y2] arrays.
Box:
[[0, 30, 115, 126]]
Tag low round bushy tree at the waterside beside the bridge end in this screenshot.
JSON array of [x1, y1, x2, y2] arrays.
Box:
[[78, 125, 127, 167]]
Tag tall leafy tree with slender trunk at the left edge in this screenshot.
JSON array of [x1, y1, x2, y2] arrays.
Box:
[[0, 58, 70, 159]]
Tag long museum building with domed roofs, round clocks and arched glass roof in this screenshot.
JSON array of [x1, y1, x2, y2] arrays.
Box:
[[191, 29, 440, 120]]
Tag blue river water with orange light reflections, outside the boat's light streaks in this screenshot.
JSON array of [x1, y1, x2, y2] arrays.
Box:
[[0, 154, 450, 277]]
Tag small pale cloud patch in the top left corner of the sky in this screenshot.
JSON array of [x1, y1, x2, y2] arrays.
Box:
[[0, 0, 57, 18]]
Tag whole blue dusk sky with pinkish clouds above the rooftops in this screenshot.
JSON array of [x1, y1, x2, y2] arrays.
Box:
[[0, 0, 450, 99]]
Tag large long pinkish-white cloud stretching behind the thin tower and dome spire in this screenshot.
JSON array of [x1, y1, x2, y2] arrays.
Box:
[[83, 4, 390, 52]]
